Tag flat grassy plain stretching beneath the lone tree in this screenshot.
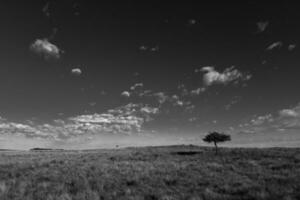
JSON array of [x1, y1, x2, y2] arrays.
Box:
[[0, 146, 300, 200]]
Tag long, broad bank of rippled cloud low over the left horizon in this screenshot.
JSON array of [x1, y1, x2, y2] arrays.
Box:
[[0, 103, 160, 141]]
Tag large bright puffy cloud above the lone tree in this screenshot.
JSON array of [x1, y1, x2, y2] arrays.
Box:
[[201, 66, 251, 86]]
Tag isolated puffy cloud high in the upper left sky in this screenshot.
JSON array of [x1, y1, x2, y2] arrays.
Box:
[[30, 39, 62, 60]]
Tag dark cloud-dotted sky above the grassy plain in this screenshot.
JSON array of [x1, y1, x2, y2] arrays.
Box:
[[0, 0, 300, 149]]
